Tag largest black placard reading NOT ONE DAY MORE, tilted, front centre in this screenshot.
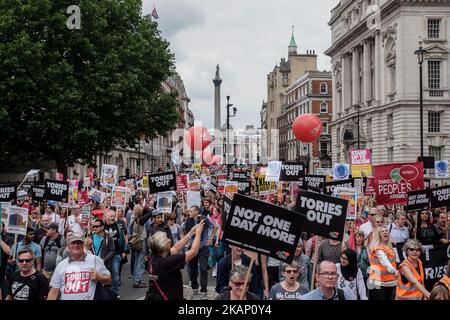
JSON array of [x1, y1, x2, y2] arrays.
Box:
[[222, 194, 305, 263]]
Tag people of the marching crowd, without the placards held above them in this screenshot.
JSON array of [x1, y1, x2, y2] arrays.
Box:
[[0, 165, 450, 300]]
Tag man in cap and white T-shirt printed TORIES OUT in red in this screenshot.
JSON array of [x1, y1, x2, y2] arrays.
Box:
[[47, 234, 111, 300]]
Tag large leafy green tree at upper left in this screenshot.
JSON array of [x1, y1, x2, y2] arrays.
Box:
[[0, 0, 178, 173]]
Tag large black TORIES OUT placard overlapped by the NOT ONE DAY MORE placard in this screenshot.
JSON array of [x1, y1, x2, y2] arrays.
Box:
[[295, 190, 348, 241]]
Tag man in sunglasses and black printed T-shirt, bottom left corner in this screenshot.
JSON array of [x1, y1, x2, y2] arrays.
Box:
[[6, 248, 49, 301]]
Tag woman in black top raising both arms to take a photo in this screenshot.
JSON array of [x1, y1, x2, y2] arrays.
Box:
[[145, 222, 205, 300]]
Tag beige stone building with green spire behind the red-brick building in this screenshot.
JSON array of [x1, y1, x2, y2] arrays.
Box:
[[261, 28, 317, 161]]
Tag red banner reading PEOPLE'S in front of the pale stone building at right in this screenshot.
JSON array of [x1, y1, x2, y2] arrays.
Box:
[[374, 162, 424, 205]]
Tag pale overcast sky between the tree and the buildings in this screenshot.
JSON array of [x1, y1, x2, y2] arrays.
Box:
[[143, 0, 339, 129]]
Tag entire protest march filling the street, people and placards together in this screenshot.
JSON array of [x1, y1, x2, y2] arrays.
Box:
[[0, 156, 450, 301]]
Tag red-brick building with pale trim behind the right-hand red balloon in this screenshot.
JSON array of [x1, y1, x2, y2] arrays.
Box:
[[278, 71, 333, 172]]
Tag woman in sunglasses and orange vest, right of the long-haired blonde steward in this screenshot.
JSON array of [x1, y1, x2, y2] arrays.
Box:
[[395, 239, 430, 300]]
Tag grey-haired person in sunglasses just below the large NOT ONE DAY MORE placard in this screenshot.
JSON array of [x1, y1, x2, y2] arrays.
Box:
[[215, 266, 260, 300]]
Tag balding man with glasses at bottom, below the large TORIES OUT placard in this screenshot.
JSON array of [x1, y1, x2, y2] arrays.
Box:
[[300, 261, 356, 300]]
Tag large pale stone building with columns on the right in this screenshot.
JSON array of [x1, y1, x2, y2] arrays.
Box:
[[326, 0, 450, 164]]
